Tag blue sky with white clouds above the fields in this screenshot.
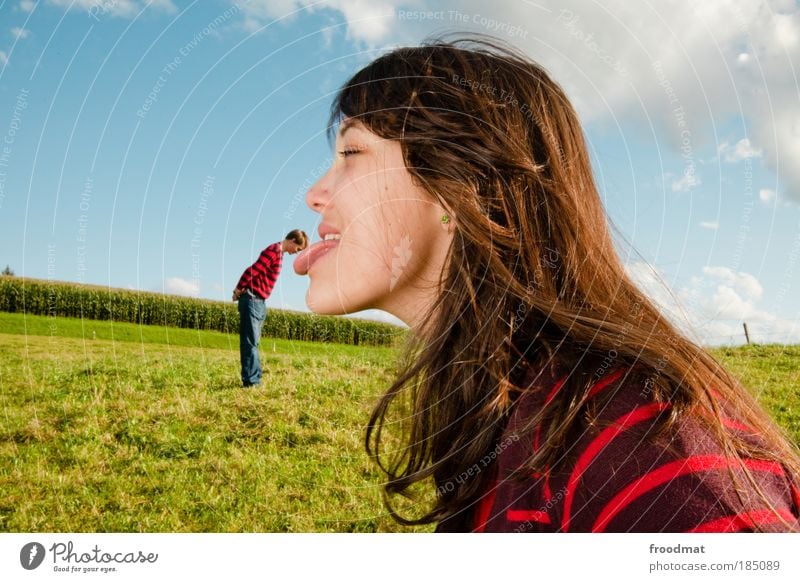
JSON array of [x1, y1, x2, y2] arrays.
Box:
[[0, 0, 800, 345]]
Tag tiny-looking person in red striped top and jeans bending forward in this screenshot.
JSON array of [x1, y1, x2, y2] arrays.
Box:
[[233, 230, 308, 388]]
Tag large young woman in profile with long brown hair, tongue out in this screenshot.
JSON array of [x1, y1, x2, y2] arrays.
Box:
[[294, 35, 800, 532]]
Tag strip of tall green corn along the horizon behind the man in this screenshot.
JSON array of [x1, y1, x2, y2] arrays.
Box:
[[0, 276, 404, 346]]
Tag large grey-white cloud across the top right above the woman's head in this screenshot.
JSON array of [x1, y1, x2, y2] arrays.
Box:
[[260, 0, 800, 200]]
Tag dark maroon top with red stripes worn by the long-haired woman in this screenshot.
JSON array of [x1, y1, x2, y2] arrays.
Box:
[[437, 370, 800, 532]]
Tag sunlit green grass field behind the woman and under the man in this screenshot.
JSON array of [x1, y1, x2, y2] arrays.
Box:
[[0, 313, 800, 532]]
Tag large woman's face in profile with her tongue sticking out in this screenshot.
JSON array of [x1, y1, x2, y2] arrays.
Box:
[[294, 119, 452, 327]]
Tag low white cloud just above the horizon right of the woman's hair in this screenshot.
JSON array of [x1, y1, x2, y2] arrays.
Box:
[[626, 262, 800, 345]]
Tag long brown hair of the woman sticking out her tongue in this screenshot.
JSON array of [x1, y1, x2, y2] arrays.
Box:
[[331, 37, 800, 524]]
